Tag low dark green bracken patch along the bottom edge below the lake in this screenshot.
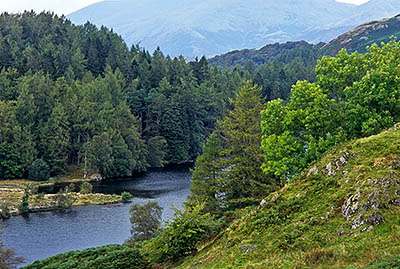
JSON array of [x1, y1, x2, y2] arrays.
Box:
[[23, 245, 149, 269]]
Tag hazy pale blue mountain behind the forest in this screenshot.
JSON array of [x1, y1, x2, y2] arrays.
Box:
[[68, 0, 400, 57]]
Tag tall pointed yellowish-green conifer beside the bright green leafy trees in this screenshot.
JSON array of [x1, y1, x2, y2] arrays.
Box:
[[190, 81, 279, 211]]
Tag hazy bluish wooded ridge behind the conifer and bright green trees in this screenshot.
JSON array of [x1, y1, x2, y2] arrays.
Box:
[[209, 41, 323, 100]]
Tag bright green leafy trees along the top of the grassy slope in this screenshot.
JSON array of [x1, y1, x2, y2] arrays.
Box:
[[261, 41, 400, 182]]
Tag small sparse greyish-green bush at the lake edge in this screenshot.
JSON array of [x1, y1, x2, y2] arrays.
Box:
[[129, 202, 162, 241]]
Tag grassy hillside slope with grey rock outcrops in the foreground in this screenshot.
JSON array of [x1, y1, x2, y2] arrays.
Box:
[[180, 125, 400, 268]]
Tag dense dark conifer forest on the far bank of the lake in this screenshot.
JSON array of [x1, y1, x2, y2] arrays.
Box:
[[0, 12, 249, 179]]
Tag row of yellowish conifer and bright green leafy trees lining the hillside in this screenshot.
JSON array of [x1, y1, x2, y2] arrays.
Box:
[[189, 41, 400, 216]]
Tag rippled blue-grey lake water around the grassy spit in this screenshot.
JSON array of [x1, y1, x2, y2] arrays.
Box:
[[2, 167, 191, 264]]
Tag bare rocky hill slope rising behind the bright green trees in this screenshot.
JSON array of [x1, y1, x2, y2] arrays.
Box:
[[322, 15, 400, 55]]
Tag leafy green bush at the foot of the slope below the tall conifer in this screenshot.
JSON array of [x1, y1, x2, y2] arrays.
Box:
[[146, 203, 217, 263]]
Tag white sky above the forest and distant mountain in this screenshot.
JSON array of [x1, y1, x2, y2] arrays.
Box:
[[0, 0, 368, 15]]
